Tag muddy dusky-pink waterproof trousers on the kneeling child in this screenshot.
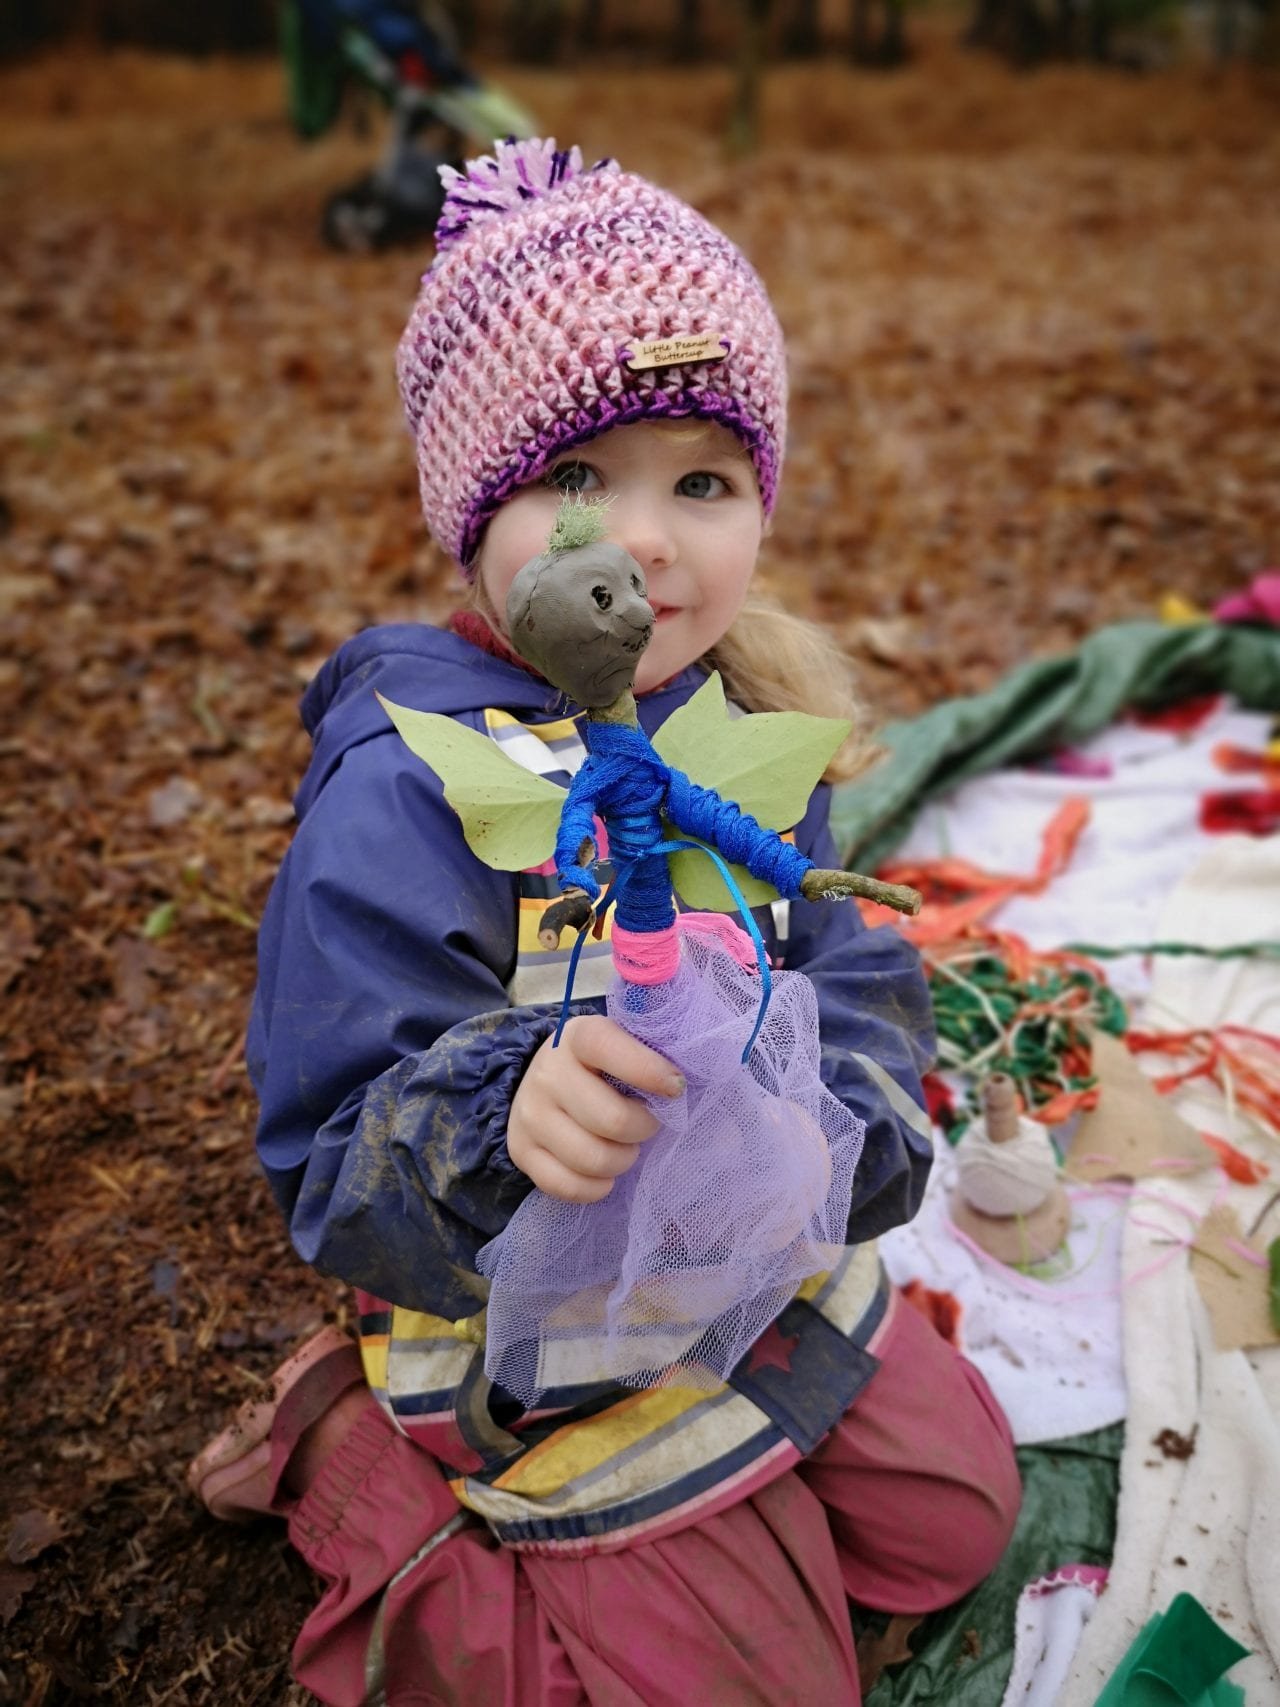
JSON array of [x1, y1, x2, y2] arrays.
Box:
[[290, 1294, 1021, 1707]]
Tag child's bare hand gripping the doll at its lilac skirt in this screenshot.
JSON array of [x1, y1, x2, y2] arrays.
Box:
[[507, 1014, 684, 1203]]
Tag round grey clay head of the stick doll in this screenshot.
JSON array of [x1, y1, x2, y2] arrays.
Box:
[[507, 541, 654, 710]]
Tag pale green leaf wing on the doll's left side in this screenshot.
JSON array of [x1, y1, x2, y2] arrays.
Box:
[[377, 693, 565, 871]]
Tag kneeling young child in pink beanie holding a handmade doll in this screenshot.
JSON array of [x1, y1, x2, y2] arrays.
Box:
[[191, 143, 1019, 1707]]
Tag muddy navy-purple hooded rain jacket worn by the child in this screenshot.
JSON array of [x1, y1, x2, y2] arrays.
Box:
[[247, 623, 934, 1320]]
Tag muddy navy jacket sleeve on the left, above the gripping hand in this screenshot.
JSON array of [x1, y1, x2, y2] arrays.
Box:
[[249, 734, 576, 1320]]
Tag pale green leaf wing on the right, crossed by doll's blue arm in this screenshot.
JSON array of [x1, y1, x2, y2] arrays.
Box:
[[654, 674, 850, 913]]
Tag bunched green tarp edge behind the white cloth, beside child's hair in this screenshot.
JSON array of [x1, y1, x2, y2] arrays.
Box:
[[831, 621, 1280, 871]]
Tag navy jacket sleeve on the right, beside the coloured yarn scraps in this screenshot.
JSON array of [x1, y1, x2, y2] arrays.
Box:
[[785, 789, 934, 1244]]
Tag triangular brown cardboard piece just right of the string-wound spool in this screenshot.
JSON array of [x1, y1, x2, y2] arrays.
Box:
[[1067, 1031, 1217, 1185]]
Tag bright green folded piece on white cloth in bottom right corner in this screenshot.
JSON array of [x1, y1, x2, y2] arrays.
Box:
[[1097, 1594, 1249, 1707]]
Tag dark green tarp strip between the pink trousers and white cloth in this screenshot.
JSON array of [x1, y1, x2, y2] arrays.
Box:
[[853, 1422, 1125, 1707]]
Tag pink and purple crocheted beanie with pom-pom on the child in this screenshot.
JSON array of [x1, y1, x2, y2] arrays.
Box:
[[396, 140, 787, 574]]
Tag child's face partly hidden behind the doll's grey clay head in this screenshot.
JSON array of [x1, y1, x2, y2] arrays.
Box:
[[476, 422, 765, 693]]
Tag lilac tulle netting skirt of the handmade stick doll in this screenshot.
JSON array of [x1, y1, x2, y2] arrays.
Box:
[[478, 915, 864, 1407]]
